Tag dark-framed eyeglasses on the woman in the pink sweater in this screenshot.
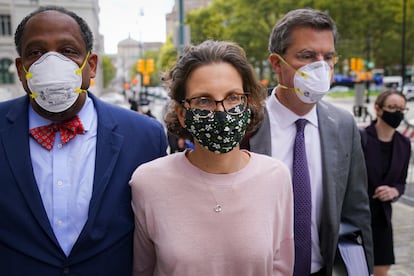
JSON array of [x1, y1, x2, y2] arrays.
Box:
[[181, 92, 248, 118]]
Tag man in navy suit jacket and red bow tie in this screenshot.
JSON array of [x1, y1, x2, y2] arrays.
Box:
[[0, 6, 167, 276]]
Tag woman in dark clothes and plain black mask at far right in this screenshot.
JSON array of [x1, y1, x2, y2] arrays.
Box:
[[361, 90, 411, 276]]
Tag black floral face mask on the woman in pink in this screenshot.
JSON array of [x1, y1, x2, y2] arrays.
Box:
[[184, 108, 251, 154]]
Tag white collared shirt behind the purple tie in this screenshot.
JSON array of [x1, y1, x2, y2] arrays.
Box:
[[266, 89, 324, 273]]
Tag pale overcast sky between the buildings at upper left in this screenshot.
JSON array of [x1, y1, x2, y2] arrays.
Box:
[[99, 0, 174, 54]]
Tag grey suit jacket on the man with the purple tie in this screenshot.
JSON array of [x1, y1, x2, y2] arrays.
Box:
[[243, 98, 374, 275]]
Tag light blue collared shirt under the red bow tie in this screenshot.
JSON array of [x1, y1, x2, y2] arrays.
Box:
[[28, 97, 98, 256]]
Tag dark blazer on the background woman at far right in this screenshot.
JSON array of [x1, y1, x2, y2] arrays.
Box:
[[363, 121, 411, 225]]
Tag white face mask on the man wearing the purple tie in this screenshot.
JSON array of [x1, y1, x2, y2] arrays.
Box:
[[277, 55, 332, 103]]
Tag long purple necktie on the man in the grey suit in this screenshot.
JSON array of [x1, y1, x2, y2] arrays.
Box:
[[292, 119, 312, 276]]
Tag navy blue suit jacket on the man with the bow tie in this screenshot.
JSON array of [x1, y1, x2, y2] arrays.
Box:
[[0, 93, 167, 276]]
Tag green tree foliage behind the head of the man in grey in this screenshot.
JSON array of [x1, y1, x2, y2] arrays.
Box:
[[186, 0, 414, 80]]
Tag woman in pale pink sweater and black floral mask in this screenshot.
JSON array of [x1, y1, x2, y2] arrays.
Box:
[[130, 41, 293, 276]]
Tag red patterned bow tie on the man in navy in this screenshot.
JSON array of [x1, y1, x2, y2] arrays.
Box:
[[29, 116, 85, 151]]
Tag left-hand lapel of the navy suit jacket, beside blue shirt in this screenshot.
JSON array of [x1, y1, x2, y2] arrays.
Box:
[[0, 97, 57, 244]]
